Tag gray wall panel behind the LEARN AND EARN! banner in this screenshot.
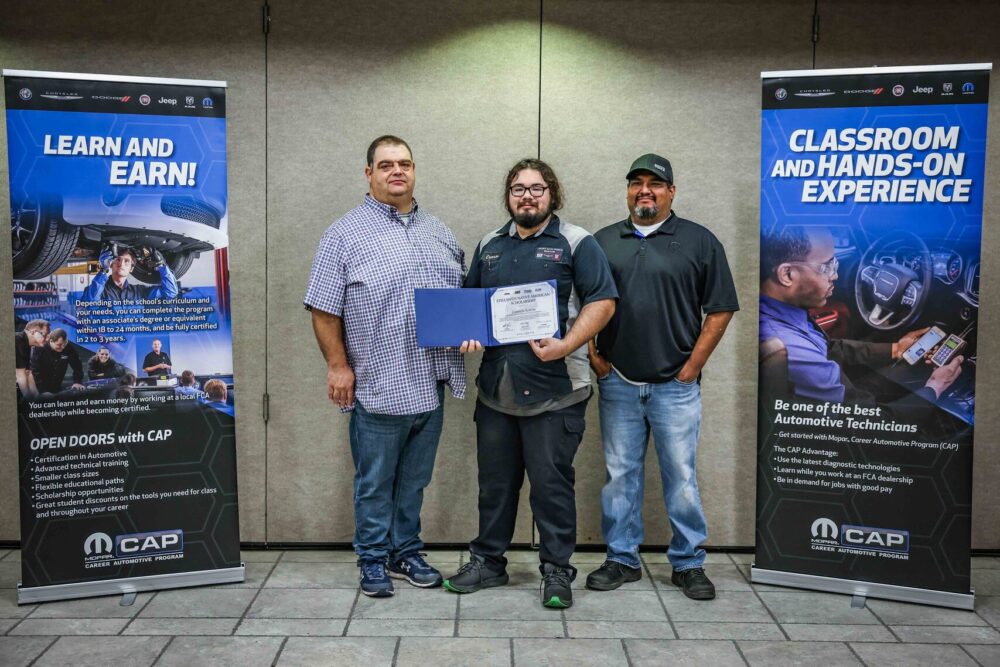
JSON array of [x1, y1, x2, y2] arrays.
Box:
[[0, 0, 264, 541]]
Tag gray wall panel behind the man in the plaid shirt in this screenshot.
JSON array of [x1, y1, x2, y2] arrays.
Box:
[[268, 1, 538, 542]]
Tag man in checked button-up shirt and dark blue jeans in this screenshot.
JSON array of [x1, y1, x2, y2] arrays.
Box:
[[305, 135, 465, 597]]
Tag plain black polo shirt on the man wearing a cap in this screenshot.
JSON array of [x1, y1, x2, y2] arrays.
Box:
[[594, 211, 740, 382]]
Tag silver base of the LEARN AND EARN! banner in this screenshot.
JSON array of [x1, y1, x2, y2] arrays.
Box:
[[17, 563, 246, 604]]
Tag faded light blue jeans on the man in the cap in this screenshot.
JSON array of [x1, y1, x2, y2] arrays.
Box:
[[598, 371, 708, 571]]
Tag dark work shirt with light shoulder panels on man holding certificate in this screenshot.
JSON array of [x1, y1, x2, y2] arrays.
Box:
[[465, 216, 618, 405]]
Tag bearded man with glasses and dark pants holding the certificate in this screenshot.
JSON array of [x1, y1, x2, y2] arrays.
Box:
[[444, 159, 618, 608]]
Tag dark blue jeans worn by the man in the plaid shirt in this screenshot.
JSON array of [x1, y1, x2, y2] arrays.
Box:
[[350, 384, 444, 563]]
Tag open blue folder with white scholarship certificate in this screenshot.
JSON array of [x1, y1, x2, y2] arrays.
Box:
[[414, 280, 559, 347]]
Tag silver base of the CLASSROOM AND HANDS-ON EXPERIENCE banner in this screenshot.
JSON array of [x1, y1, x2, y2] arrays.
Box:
[[750, 565, 976, 611]]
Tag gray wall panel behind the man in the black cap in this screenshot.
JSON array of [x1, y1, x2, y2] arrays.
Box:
[[541, 0, 812, 545]]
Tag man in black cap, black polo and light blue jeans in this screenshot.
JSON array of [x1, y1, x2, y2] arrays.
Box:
[[587, 154, 739, 600]]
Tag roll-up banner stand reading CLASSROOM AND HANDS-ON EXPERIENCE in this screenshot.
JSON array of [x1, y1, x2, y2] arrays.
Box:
[[751, 64, 991, 609]]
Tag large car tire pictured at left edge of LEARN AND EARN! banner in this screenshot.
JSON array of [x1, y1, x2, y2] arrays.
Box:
[[10, 200, 80, 280]]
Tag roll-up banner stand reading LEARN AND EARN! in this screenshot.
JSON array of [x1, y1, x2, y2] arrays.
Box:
[[3, 70, 244, 603]]
